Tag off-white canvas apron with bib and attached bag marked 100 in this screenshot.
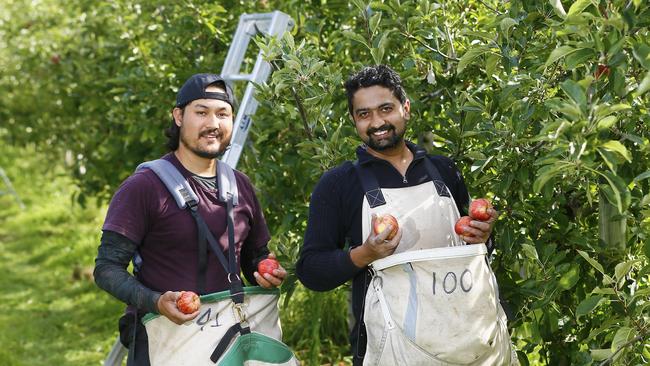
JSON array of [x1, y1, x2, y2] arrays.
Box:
[[362, 181, 518, 366]]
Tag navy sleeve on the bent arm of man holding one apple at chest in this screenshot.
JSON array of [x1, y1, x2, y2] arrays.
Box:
[[296, 171, 362, 291]]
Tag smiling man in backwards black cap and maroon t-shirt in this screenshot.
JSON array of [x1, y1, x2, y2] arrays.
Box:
[[94, 74, 286, 365]]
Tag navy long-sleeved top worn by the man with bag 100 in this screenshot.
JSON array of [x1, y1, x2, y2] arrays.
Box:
[[296, 142, 478, 364]]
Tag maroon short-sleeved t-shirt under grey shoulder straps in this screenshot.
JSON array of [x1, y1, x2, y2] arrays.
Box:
[[103, 153, 270, 292]]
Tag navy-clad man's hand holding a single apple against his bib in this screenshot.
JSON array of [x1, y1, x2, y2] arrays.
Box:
[[350, 214, 402, 268]]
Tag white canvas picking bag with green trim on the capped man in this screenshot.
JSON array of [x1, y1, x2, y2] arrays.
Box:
[[142, 287, 299, 366]]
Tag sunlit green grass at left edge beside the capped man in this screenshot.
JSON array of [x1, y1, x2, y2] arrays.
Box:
[[0, 146, 123, 366]]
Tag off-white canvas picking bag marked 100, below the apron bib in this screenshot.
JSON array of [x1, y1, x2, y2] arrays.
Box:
[[364, 244, 518, 366]]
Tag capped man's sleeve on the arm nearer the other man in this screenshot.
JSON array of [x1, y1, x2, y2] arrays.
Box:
[[238, 173, 271, 285]]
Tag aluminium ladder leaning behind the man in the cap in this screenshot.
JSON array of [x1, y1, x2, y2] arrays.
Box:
[[104, 10, 294, 366]]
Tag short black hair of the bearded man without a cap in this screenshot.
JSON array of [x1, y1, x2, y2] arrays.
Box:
[[345, 65, 406, 115]]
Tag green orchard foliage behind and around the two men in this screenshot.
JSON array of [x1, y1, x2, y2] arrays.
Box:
[[0, 0, 650, 365]]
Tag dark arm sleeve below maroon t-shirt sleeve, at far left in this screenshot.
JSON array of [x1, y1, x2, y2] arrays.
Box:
[[93, 230, 160, 313]]
